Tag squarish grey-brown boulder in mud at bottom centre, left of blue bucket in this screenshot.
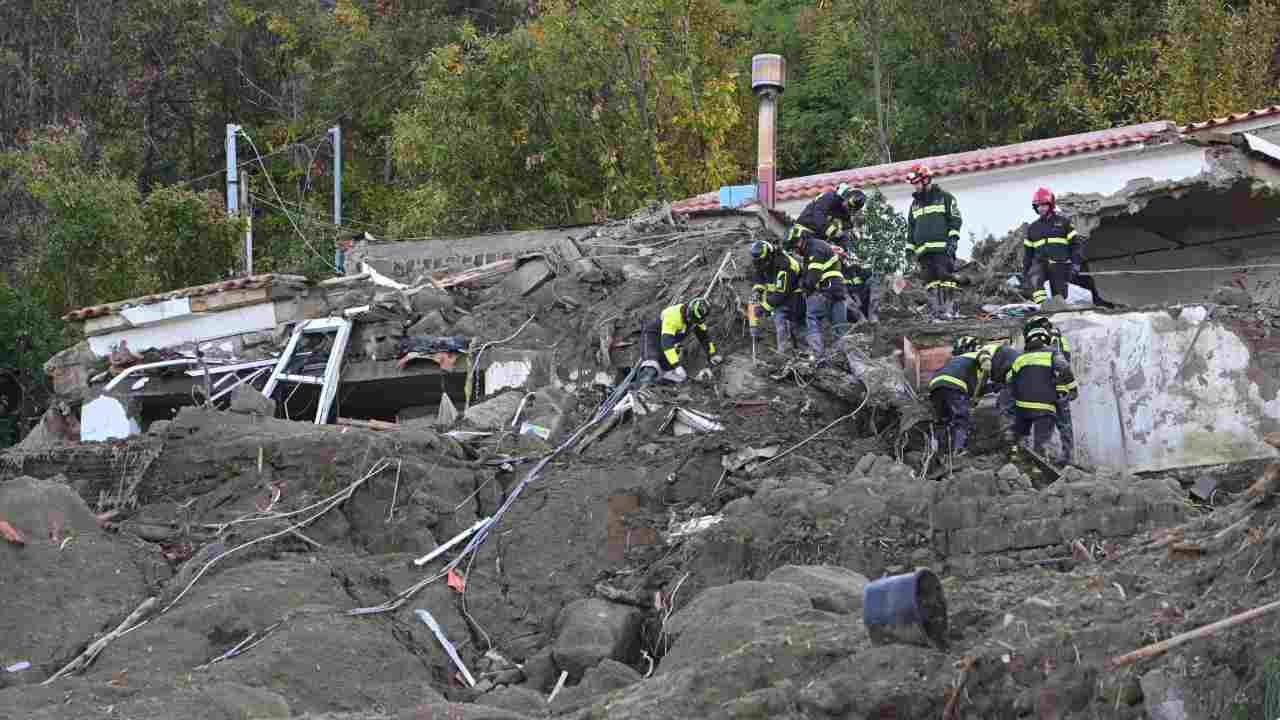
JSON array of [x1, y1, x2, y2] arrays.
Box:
[[552, 598, 640, 679]]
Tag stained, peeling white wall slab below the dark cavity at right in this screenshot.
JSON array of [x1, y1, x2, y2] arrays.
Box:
[[1055, 306, 1280, 473]]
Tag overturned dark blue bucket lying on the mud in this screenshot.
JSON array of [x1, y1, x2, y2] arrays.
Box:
[[863, 568, 947, 648]]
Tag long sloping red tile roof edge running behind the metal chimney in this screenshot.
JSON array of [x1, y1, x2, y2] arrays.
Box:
[[672, 120, 1176, 213]]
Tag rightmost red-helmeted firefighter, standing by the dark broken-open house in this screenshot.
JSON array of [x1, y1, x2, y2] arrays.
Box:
[[1023, 187, 1084, 305]]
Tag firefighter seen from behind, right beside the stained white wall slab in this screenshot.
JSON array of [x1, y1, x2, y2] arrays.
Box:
[[1006, 327, 1075, 454]]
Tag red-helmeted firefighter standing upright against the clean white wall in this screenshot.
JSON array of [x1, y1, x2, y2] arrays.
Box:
[[906, 164, 961, 320]]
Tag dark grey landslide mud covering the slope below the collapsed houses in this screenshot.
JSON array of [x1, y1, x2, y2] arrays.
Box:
[[0, 210, 1280, 720]]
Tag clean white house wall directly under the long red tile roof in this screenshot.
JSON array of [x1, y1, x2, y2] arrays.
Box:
[[778, 142, 1204, 258]]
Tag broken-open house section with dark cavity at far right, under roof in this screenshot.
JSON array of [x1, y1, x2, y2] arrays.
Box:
[[1062, 136, 1280, 305]]
